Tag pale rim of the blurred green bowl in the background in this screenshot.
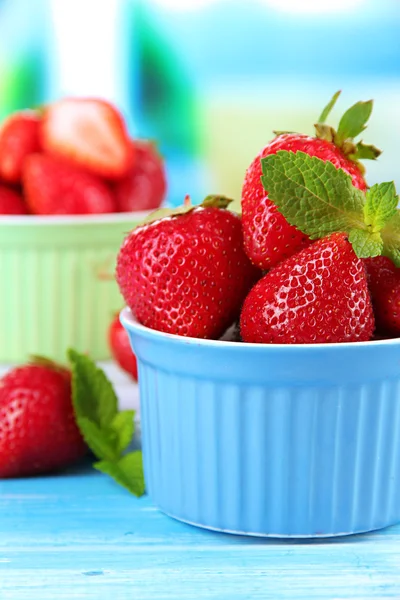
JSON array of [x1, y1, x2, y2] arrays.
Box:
[[0, 210, 154, 227]]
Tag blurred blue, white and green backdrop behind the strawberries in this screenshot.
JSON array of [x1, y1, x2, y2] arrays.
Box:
[[0, 0, 400, 211]]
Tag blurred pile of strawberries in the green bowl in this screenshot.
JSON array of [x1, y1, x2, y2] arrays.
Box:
[[0, 98, 166, 215]]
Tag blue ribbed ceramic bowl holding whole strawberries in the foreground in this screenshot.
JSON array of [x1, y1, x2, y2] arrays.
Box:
[[121, 309, 400, 538]]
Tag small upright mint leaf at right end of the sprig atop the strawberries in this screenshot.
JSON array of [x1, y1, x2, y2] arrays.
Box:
[[364, 181, 398, 232]]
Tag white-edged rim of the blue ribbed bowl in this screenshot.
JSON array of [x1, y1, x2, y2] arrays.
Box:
[[120, 306, 400, 352]]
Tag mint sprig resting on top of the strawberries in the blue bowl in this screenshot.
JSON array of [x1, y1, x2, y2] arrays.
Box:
[[261, 150, 400, 267]]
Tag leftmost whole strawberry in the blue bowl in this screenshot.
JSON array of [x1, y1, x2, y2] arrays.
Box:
[[116, 197, 257, 339]]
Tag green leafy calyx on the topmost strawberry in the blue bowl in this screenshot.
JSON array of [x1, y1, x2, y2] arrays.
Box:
[[315, 90, 382, 173]]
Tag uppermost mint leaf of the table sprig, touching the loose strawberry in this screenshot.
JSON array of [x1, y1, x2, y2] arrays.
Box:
[[68, 350, 118, 429]]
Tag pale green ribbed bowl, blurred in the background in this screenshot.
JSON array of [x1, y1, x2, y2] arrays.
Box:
[[0, 212, 148, 364]]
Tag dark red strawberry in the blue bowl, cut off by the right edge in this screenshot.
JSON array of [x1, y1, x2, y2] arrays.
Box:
[[364, 256, 400, 336]]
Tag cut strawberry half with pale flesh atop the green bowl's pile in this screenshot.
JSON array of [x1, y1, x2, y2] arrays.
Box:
[[42, 98, 133, 179]]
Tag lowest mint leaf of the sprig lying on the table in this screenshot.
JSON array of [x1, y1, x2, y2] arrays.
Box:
[[93, 450, 145, 496]]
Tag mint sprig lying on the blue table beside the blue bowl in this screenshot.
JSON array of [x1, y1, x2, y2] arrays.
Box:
[[68, 350, 145, 496]]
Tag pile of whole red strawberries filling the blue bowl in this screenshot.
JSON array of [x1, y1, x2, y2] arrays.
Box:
[[116, 94, 400, 344]]
